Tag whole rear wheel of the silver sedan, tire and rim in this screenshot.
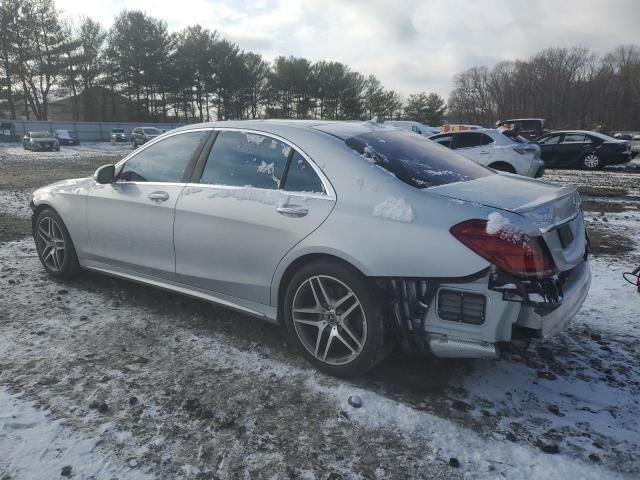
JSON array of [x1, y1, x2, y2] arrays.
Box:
[[284, 261, 389, 377]]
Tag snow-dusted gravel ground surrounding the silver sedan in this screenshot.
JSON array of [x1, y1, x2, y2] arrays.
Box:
[[0, 145, 640, 480]]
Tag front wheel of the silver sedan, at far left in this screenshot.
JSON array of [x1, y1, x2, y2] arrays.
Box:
[[33, 208, 80, 278]]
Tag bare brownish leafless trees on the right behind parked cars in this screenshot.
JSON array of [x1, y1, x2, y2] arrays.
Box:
[[448, 45, 640, 130]]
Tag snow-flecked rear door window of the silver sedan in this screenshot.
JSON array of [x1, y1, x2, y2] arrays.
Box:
[[200, 130, 293, 189]]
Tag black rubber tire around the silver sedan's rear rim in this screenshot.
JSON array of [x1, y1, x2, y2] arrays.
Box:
[[283, 261, 392, 377]]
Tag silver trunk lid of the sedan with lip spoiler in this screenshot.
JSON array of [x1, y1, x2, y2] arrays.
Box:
[[429, 174, 586, 271]]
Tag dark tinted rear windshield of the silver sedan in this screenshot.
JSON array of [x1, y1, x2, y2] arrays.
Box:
[[345, 130, 494, 188]]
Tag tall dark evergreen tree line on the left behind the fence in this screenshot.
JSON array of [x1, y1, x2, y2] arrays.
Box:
[[0, 0, 446, 125]]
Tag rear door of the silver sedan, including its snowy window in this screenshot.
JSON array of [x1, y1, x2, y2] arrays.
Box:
[[175, 129, 335, 305]]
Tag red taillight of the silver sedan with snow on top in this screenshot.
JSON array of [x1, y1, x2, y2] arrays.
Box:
[[450, 219, 553, 278]]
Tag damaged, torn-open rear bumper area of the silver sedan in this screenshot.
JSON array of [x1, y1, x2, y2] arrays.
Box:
[[378, 260, 591, 358]]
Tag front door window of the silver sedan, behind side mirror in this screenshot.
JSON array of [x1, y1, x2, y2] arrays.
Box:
[[118, 132, 209, 183]]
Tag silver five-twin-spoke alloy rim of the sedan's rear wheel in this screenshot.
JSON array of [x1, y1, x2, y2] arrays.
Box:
[[292, 275, 367, 365]]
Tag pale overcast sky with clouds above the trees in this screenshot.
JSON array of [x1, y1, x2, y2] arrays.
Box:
[[56, 0, 640, 97]]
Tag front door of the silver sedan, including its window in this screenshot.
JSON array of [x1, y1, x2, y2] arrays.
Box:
[[87, 129, 211, 279]]
